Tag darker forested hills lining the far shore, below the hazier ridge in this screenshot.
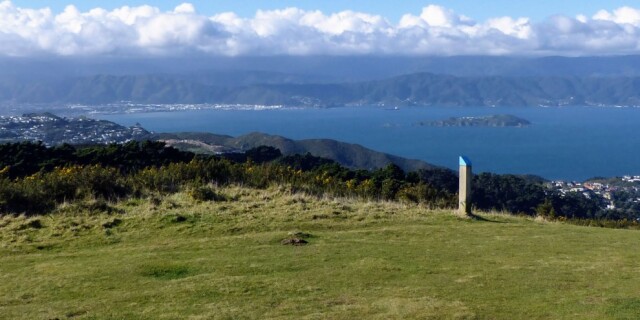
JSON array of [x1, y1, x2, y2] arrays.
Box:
[[0, 73, 640, 107]]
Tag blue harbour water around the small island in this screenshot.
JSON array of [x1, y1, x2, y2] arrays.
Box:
[[97, 107, 640, 181]]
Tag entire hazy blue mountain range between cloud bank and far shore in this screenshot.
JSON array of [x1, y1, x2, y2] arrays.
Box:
[[0, 56, 640, 107]]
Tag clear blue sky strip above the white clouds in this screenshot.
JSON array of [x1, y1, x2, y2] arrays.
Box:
[[14, 0, 640, 22]]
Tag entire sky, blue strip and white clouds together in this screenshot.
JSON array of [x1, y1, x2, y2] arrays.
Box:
[[0, 0, 640, 57]]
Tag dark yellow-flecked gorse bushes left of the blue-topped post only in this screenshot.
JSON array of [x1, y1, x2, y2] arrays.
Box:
[[0, 142, 462, 215]]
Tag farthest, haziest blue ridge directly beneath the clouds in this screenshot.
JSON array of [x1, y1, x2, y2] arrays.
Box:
[[6, 55, 640, 79]]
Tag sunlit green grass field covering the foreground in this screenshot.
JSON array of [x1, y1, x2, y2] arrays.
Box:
[[0, 188, 640, 319]]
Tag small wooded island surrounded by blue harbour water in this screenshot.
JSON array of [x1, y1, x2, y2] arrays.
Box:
[[418, 114, 531, 127]]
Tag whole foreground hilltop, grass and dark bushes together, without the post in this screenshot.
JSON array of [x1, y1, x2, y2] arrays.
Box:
[[0, 141, 640, 319]]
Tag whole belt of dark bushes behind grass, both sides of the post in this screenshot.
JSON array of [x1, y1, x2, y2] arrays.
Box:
[[0, 141, 620, 220]]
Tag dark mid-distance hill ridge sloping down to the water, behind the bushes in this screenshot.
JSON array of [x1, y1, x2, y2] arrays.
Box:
[[147, 132, 437, 172]]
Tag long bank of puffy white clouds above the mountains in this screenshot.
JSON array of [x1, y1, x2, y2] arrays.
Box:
[[0, 1, 640, 56]]
